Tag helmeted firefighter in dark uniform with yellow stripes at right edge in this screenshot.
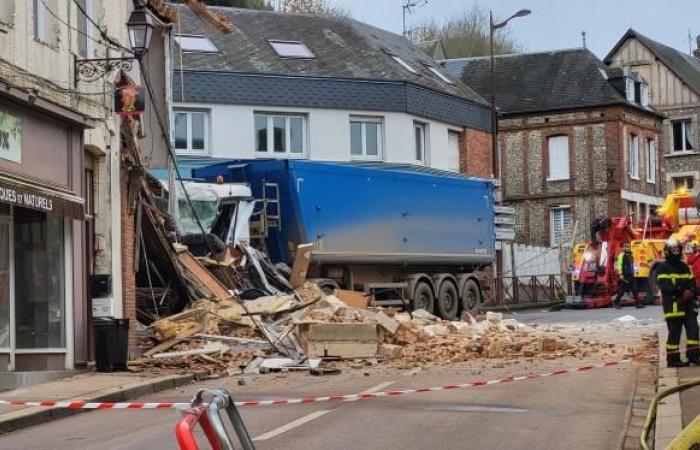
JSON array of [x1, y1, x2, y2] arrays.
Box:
[[656, 238, 700, 367]]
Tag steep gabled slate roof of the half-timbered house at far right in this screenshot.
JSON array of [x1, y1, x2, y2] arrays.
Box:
[[604, 28, 700, 95]]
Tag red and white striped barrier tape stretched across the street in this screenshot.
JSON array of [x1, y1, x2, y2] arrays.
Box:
[[0, 358, 639, 409]]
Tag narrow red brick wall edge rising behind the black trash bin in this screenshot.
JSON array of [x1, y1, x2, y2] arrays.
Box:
[[120, 166, 136, 355]]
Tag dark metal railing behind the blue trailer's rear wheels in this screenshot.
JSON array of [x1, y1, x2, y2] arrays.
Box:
[[486, 275, 566, 306]]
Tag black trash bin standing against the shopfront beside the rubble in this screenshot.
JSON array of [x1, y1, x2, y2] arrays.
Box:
[[93, 318, 129, 372]]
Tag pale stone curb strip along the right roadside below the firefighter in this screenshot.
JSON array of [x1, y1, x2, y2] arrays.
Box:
[[654, 326, 683, 449]]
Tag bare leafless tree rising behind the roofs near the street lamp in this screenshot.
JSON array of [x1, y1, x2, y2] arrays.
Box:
[[409, 5, 523, 58]]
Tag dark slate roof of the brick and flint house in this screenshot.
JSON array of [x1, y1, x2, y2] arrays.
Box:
[[442, 48, 646, 114]]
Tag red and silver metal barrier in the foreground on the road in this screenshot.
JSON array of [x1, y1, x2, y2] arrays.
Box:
[[175, 389, 255, 450]]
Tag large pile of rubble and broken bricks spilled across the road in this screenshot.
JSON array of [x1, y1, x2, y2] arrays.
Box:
[[130, 258, 624, 377]]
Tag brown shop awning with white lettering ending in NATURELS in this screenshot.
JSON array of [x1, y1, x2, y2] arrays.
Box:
[[0, 175, 85, 220]]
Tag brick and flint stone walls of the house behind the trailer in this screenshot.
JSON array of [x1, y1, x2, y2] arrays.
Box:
[[499, 107, 663, 246]]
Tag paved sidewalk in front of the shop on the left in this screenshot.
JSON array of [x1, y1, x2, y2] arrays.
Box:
[[0, 372, 193, 433]]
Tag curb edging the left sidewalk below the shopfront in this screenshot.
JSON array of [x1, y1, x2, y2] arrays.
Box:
[[0, 374, 195, 434]]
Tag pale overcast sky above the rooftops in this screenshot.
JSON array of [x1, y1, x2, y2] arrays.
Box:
[[331, 0, 700, 58]]
